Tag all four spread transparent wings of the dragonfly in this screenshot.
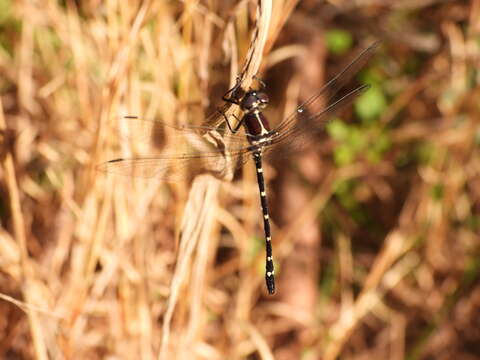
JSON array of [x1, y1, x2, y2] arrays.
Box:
[[97, 42, 379, 181]]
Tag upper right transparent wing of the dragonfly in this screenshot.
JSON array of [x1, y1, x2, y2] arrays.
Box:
[[275, 41, 380, 133]]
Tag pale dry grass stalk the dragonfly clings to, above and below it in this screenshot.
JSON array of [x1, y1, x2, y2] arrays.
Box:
[[158, 0, 272, 359]]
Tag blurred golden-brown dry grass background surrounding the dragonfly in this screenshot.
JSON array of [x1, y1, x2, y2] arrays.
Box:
[[0, 0, 480, 359]]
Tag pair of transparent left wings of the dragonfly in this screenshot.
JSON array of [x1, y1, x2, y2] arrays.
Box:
[[97, 116, 253, 181]]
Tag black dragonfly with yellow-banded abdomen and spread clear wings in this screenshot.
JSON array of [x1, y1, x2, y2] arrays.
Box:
[[98, 42, 379, 295]]
